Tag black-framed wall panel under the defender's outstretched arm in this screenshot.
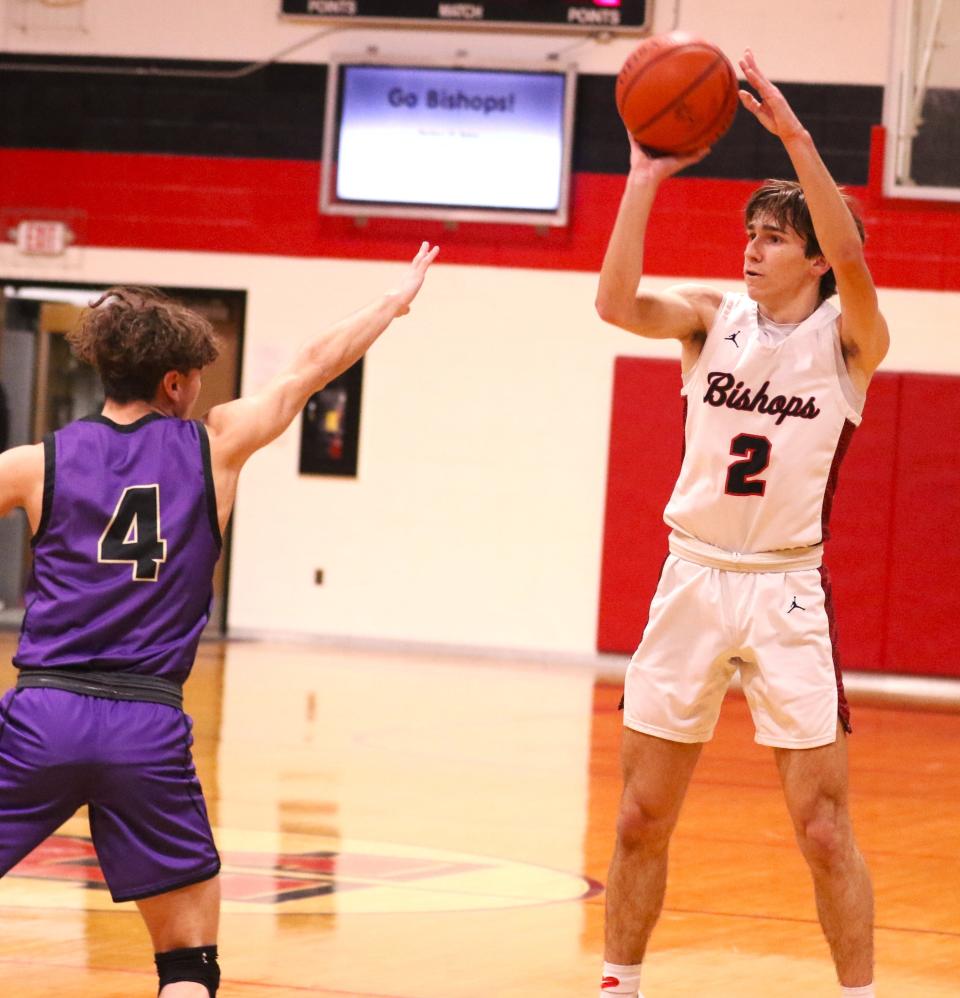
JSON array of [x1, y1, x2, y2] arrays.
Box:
[[300, 357, 363, 478]]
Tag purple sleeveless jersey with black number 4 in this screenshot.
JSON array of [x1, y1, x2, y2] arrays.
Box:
[[13, 413, 221, 683]]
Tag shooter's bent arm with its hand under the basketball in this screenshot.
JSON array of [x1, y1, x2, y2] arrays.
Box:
[[596, 133, 721, 360]]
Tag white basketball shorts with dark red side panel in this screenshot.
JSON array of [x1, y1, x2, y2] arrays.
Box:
[[623, 555, 850, 749]]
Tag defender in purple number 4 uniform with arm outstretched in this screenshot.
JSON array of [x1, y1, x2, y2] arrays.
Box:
[[0, 243, 438, 998]]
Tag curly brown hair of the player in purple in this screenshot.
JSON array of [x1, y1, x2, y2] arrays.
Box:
[[67, 287, 220, 403]]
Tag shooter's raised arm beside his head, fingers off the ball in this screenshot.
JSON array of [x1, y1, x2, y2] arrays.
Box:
[[740, 49, 890, 389]]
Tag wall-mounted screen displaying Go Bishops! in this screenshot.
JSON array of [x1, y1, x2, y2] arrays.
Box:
[[320, 59, 576, 225]]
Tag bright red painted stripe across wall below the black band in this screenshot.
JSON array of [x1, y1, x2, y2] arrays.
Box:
[[0, 128, 960, 290]]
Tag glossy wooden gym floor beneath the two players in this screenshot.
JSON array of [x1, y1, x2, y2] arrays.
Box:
[[0, 635, 960, 998]]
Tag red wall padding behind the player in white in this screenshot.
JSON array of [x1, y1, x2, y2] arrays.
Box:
[[597, 357, 960, 676]]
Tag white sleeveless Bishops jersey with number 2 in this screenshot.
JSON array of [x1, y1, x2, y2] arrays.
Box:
[[664, 294, 863, 570]]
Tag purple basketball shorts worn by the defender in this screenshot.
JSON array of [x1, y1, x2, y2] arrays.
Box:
[[0, 689, 220, 901]]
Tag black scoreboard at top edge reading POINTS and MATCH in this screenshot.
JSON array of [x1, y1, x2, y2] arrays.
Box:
[[280, 0, 653, 34]]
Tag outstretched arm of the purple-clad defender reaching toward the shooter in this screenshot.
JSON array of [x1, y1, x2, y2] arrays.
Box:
[[206, 243, 439, 471]]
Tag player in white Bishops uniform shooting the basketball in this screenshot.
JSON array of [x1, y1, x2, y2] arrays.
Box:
[[597, 50, 889, 998]]
